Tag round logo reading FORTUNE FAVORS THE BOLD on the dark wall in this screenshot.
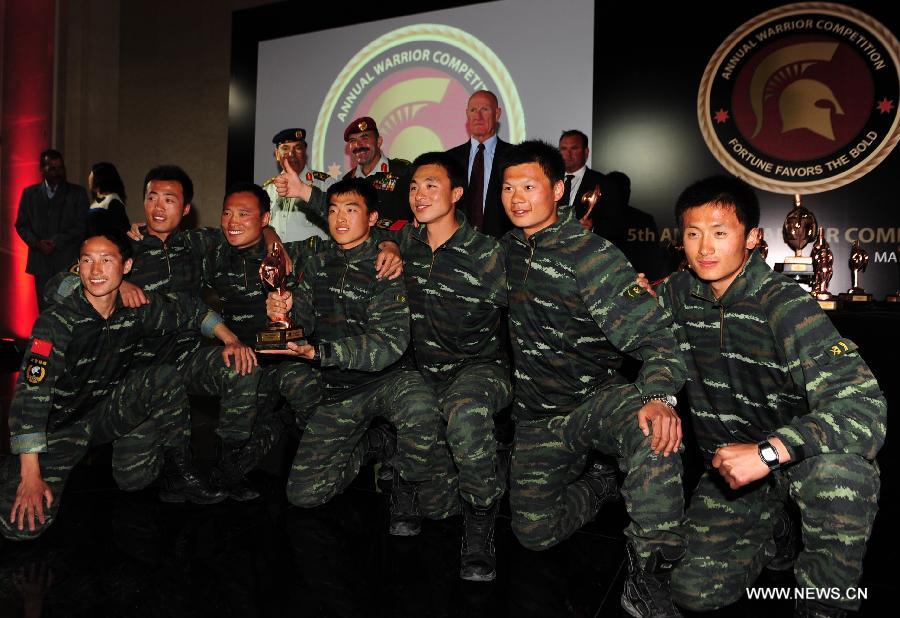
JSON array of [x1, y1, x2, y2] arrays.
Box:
[[697, 3, 900, 193]]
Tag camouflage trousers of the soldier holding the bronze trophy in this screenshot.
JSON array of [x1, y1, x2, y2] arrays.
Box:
[[287, 371, 441, 507]]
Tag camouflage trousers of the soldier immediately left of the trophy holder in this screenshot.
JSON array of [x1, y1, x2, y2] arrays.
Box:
[[238, 358, 322, 473]]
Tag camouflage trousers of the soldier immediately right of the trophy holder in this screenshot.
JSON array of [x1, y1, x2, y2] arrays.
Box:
[[419, 363, 512, 519]]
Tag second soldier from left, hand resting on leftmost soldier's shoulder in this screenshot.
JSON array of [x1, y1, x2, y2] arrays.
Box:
[[51, 165, 259, 500]]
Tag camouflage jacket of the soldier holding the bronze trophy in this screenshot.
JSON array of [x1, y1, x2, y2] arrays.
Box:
[[291, 237, 409, 397]]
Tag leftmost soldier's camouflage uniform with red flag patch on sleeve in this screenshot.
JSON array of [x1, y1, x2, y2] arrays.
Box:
[[0, 291, 213, 539]]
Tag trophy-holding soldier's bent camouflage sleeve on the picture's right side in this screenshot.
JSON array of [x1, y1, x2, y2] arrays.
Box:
[[321, 277, 409, 371]]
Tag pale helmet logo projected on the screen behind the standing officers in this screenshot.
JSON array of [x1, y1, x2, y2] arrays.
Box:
[[312, 24, 525, 177]]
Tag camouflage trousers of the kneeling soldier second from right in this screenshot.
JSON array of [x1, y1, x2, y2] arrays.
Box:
[[509, 384, 684, 559]]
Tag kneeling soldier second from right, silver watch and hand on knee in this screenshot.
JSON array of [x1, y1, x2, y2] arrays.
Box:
[[501, 142, 684, 616]]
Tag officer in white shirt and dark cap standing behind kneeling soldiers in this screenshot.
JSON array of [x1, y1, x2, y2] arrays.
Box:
[[262, 128, 335, 242]]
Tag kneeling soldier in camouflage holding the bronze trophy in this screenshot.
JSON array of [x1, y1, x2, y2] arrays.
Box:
[[266, 179, 440, 507]]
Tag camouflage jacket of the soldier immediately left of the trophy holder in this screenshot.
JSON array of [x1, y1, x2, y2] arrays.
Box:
[[203, 236, 319, 347]]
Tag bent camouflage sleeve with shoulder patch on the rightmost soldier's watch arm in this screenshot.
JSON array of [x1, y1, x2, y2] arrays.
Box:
[[764, 281, 887, 460]]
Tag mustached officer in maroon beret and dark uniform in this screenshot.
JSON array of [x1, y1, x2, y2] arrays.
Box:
[[344, 116, 412, 224]]
